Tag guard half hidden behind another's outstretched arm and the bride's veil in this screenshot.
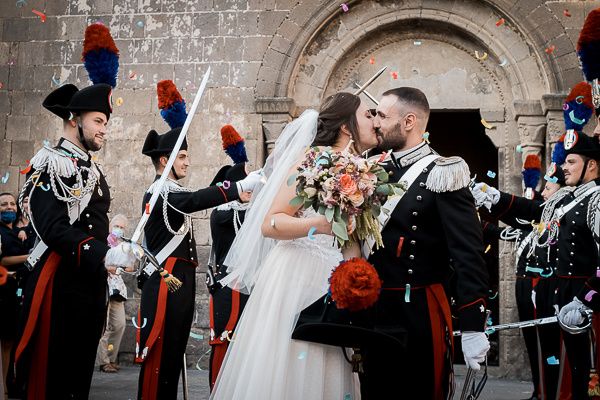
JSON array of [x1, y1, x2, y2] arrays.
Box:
[[206, 125, 249, 390]]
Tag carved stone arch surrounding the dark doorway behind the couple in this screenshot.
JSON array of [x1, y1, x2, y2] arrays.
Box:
[[256, 0, 581, 376]]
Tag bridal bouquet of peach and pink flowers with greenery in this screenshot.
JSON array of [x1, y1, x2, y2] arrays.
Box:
[[288, 147, 404, 248]]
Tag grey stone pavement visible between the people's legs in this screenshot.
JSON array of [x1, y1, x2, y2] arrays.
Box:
[[90, 366, 531, 400]]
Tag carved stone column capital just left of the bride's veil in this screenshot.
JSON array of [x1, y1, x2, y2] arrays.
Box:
[[255, 97, 294, 159]]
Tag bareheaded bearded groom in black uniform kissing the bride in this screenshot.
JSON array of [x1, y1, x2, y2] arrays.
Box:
[[360, 87, 489, 399]]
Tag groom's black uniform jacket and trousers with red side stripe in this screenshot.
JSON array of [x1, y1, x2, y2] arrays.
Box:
[[360, 150, 489, 399]]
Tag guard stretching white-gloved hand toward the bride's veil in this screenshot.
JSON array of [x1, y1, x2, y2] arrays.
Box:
[[136, 81, 260, 400]]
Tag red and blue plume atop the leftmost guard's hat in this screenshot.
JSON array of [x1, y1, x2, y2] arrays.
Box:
[[82, 23, 119, 88]]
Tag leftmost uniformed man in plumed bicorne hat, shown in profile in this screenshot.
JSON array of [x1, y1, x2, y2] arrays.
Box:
[[15, 24, 135, 400]]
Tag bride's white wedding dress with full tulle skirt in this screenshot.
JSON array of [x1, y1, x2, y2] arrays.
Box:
[[211, 210, 360, 400]]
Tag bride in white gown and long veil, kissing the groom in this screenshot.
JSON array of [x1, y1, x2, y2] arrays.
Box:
[[211, 93, 377, 400]]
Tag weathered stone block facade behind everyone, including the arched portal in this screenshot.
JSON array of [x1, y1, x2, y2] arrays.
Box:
[[0, 0, 600, 376]]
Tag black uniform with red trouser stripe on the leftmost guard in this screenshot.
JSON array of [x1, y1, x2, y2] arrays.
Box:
[[15, 141, 110, 400]]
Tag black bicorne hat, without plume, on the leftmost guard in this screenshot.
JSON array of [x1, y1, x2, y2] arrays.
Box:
[[42, 83, 112, 121]]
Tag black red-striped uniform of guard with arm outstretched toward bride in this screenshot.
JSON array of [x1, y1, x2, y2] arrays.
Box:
[[136, 176, 239, 400]]
